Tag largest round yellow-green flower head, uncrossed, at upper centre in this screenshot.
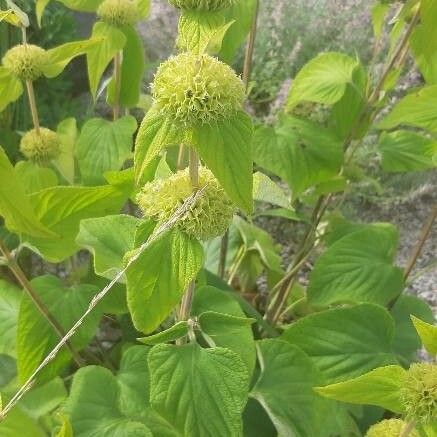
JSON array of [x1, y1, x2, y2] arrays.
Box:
[[152, 53, 244, 126]]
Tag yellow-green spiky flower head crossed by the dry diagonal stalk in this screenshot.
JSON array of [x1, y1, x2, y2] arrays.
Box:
[[137, 167, 235, 240]]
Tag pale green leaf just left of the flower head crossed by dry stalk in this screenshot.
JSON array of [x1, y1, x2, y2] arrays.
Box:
[[76, 215, 139, 279]]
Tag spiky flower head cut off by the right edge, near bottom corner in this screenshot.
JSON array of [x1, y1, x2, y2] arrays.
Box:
[[401, 363, 437, 423]]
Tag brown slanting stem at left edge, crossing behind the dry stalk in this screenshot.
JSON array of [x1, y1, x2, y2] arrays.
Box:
[[0, 241, 83, 367]]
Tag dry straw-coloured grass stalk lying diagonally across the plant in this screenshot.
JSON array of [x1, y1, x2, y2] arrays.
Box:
[[0, 189, 204, 422]]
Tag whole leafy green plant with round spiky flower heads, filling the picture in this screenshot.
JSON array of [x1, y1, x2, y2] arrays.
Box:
[[0, 0, 437, 437]]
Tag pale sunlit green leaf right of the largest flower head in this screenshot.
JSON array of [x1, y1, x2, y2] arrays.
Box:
[[286, 52, 360, 110]]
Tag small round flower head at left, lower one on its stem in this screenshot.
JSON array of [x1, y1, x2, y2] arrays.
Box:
[[20, 127, 60, 164]]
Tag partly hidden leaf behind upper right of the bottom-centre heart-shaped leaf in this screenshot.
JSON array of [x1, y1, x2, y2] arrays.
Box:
[[198, 311, 255, 376]]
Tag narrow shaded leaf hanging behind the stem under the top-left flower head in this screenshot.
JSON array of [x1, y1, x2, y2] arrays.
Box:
[[108, 26, 146, 108]]
